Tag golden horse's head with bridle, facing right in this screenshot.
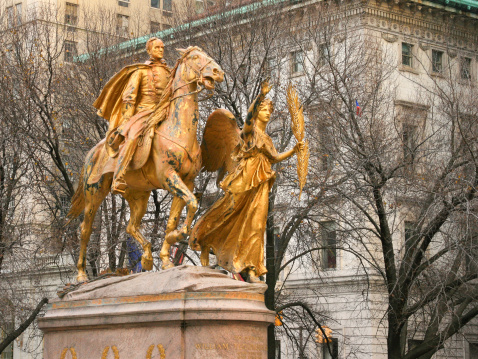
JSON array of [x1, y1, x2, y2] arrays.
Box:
[[178, 46, 224, 90]]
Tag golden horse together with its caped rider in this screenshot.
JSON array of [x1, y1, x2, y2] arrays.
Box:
[[68, 39, 224, 282]]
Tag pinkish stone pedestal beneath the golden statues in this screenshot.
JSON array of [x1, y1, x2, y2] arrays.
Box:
[[39, 266, 274, 359]]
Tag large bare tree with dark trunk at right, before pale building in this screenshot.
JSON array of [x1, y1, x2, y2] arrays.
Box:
[[294, 6, 478, 359]]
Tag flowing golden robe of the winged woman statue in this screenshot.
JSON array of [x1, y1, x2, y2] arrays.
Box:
[[190, 130, 277, 276]]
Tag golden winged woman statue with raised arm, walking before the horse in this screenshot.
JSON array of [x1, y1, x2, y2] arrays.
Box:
[[189, 82, 304, 282]]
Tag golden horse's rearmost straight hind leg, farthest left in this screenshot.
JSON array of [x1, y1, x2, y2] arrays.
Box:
[[76, 178, 111, 283]]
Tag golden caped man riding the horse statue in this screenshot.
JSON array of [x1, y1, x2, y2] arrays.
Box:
[[93, 37, 171, 193]]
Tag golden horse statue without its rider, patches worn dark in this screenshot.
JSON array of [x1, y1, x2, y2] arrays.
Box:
[[68, 47, 224, 282]]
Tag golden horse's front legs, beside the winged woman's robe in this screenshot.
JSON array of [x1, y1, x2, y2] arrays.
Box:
[[161, 171, 198, 268]]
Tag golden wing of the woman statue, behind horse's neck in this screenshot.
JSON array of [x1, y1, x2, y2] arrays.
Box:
[[201, 109, 241, 183]]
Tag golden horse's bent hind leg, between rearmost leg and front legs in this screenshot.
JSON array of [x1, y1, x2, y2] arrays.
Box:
[[122, 188, 153, 270]]
